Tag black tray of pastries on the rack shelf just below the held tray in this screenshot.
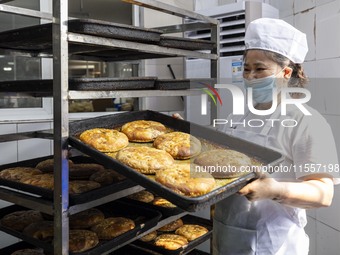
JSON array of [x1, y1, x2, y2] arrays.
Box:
[[0, 153, 136, 205]]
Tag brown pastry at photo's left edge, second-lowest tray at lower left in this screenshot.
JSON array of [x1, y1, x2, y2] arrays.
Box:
[[0, 210, 44, 232]]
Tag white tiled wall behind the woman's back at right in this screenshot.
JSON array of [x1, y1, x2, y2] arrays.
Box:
[[278, 0, 340, 255]]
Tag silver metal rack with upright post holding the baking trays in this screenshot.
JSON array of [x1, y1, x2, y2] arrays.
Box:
[[0, 0, 219, 255]]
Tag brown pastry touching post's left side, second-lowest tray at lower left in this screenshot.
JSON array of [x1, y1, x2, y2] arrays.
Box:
[[22, 221, 54, 241]]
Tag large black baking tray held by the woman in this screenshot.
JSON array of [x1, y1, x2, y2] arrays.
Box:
[[69, 110, 283, 212]]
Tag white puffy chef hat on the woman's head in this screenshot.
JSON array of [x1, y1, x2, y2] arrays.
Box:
[[245, 18, 308, 64]]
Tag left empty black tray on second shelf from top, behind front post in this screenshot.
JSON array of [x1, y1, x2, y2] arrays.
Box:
[[0, 77, 157, 96]]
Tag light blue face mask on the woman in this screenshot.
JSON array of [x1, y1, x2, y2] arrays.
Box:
[[244, 70, 282, 103]]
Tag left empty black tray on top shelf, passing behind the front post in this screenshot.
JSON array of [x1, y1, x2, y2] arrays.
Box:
[[0, 19, 162, 52]]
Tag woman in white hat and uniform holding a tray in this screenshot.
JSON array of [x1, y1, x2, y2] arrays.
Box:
[[213, 18, 339, 255]]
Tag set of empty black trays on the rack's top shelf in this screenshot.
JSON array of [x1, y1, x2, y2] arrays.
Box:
[[0, 19, 214, 61]]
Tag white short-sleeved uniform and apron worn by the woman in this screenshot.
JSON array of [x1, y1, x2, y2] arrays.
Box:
[[213, 106, 339, 255]]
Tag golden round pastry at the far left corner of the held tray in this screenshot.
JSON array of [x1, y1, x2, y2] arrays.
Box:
[[79, 128, 129, 152]]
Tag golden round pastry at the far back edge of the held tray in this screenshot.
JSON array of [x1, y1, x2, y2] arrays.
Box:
[[121, 120, 166, 142]]
